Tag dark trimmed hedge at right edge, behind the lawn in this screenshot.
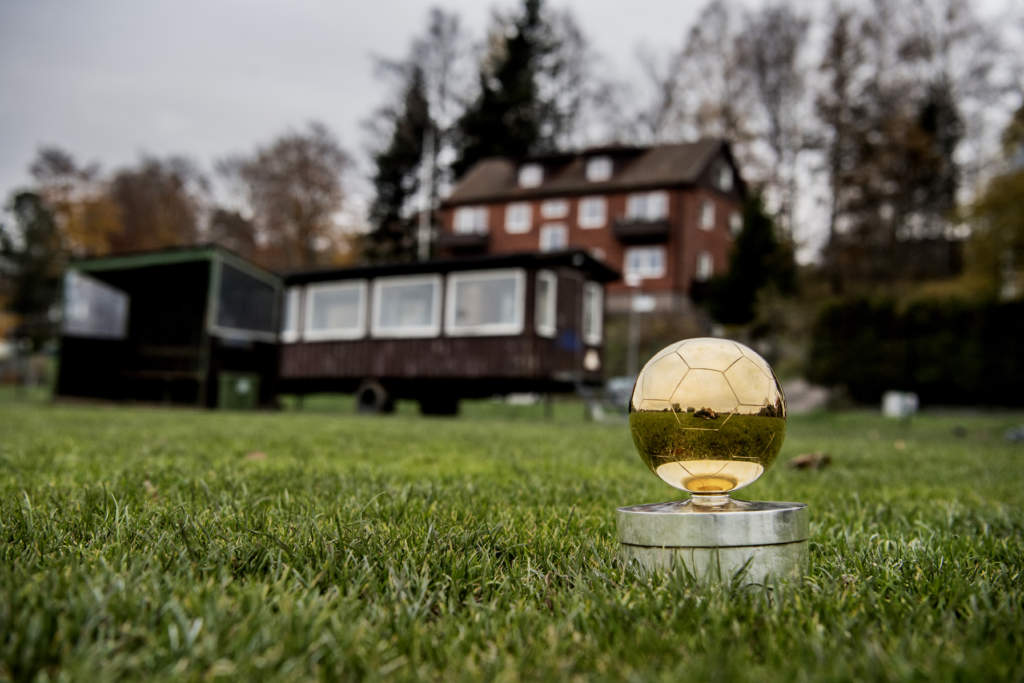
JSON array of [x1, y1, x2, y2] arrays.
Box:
[[807, 298, 1024, 405]]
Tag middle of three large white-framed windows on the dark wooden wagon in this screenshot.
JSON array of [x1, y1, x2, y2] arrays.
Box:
[[372, 275, 441, 337]]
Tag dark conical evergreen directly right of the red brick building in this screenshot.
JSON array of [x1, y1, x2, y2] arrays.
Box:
[[694, 194, 797, 325]]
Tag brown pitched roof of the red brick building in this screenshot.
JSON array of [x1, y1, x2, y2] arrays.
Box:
[[444, 138, 738, 206]]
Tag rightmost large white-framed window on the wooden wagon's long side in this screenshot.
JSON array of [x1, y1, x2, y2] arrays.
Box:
[[444, 268, 525, 336]]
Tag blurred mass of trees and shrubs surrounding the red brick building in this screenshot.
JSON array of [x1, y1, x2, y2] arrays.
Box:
[[0, 0, 1024, 404]]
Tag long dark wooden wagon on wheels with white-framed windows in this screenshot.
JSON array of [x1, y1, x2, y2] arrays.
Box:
[[278, 250, 618, 414]]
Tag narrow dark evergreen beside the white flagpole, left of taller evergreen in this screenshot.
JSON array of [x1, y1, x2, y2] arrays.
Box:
[[362, 65, 435, 260]]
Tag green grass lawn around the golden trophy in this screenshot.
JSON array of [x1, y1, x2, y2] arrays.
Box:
[[0, 400, 1024, 682]]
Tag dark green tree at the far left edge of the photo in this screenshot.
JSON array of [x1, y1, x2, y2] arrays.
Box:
[[0, 193, 66, 350]]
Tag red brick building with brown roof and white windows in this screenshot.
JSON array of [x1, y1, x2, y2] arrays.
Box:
[[438, 139, 745, 311]]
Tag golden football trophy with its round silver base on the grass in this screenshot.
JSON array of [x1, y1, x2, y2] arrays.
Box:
[[616, 338, 808, 584]]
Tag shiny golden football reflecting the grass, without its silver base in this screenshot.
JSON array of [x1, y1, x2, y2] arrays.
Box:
[[630, 338, 785, 496]]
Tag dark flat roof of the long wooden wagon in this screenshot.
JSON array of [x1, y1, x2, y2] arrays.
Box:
[[285, 249, 620, 285]]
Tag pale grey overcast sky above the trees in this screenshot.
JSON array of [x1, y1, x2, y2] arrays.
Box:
[[0, 0, 712, 206]]
